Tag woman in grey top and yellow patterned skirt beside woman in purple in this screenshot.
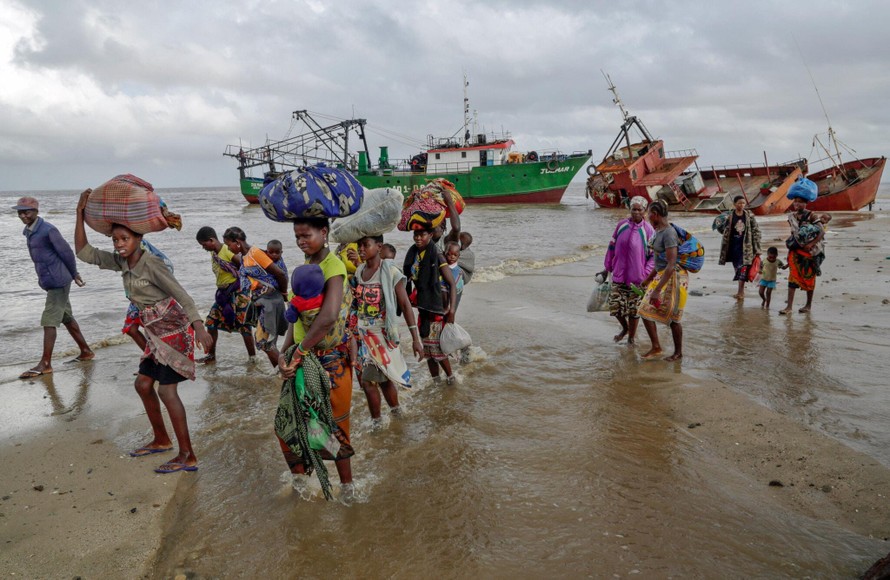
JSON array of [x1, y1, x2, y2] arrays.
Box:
[[639, 200, 689, 361]]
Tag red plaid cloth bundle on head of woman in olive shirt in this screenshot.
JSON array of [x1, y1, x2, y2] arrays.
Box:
[[84, 173, 182, 236]]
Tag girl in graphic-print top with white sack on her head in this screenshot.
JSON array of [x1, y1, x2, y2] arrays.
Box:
[[349, 236, 423, 423]]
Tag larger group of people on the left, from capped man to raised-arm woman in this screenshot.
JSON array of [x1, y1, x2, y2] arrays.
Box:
[[13, 190, 475, 503]]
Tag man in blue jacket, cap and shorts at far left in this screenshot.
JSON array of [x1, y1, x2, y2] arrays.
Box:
[[12, 197, 95, 379]]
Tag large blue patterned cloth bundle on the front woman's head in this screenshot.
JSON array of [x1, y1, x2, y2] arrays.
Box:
[[259, 163, 365, 222]]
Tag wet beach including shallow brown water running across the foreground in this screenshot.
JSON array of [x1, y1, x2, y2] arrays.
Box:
[[0, 188, 890, 578]]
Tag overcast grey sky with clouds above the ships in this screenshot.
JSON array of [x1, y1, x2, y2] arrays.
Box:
[[0, 0, 890, 191]]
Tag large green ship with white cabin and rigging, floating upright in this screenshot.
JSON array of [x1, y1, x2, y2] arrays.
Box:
[[223, 104, 591, 204]]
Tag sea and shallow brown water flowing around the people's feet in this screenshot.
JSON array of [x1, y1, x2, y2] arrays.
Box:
[[0, 185, 890, 578]]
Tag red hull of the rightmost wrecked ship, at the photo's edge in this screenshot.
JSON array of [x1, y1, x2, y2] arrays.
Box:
[[807, 157, 887, 211]]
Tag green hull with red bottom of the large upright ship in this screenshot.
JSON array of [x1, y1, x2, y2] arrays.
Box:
[[241, 155, 590, 204]]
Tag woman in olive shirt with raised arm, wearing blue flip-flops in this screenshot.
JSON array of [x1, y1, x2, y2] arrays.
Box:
[[74, 190, 213, 473]]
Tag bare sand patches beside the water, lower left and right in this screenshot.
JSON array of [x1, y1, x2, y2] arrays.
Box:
[[0, 208, 890, 578]]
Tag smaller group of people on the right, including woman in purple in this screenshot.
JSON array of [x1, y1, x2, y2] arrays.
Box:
[[603, 179, 831, 361]]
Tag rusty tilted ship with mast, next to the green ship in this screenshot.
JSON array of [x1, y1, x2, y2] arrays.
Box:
[[587, 76, 807, 215]]
